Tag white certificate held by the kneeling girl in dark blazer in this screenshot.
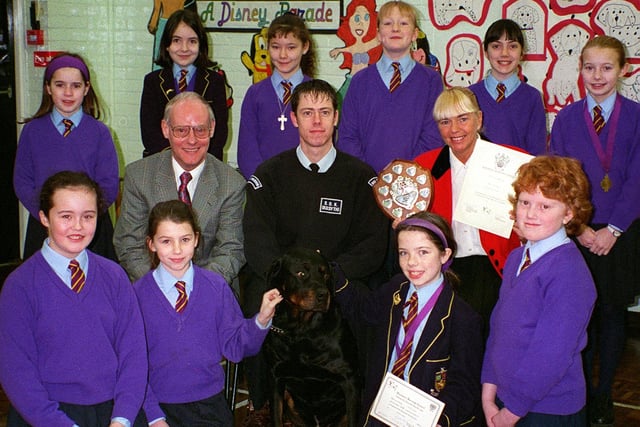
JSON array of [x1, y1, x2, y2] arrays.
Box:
[[370, 372, 444, 427]]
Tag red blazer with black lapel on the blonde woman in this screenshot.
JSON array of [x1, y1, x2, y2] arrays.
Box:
[[415, 146, 522, 277]]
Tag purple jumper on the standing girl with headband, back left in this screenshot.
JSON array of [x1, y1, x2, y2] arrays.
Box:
[[13, 114, 120, 218]]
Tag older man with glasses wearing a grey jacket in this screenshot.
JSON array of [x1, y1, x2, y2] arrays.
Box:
[[113, 92, 246, 284]]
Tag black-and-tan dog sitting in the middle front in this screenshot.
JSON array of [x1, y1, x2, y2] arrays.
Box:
[[264, 248, 360, 427]]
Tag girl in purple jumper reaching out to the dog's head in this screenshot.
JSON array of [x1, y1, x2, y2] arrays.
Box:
[[134, 200, 282, 427]]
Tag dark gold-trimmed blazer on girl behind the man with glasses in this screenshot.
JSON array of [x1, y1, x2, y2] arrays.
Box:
[[140, 68, 229, 160]]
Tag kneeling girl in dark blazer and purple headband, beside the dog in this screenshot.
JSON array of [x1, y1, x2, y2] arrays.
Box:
[[336, 212, 484, 426]]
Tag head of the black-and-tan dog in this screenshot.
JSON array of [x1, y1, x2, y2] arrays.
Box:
[[267, 248, 333, 314]]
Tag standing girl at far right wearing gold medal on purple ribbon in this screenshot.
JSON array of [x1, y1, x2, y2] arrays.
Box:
[[551, 36, 640, 424]]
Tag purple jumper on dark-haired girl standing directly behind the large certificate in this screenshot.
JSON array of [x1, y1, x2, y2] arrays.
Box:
[[469, 80, 547, 156]]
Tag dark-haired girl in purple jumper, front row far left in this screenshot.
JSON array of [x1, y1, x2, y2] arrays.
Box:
[[0, 171, 147, 427]]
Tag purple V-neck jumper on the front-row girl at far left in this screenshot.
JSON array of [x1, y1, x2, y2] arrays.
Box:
[[0, 252, 147, 427]]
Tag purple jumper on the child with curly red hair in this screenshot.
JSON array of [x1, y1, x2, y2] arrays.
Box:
[[482, 242, 596, 417]]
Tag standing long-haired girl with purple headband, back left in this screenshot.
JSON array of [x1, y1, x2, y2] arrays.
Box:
[[13, 52, 119, 260]]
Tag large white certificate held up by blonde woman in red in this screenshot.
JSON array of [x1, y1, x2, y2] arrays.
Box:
[[453, 139, 533, 238]]
